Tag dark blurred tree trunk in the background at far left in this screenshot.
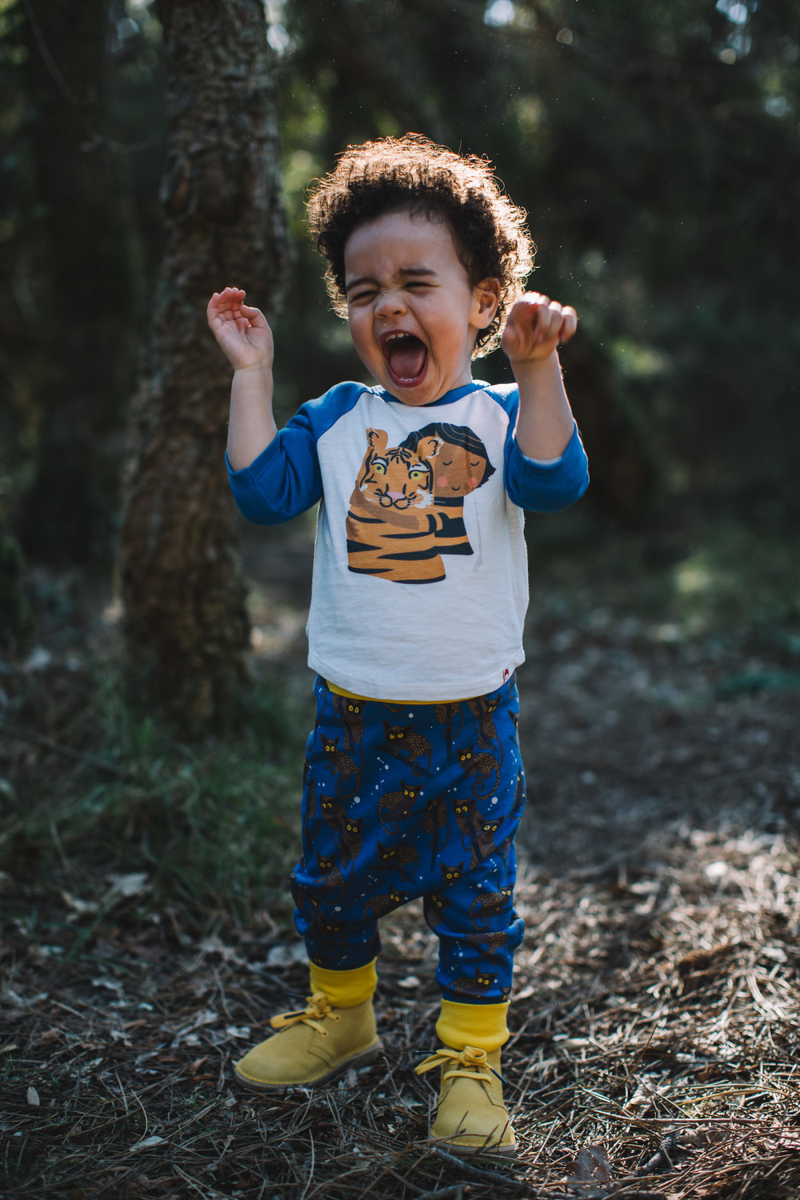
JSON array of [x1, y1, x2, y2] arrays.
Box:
[[19, 0, 137, 564]]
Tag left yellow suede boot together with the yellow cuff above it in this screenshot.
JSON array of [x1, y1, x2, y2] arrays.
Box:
[[234, 962, 380, 1092]]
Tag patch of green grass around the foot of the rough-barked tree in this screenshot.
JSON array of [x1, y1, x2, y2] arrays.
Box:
[[1, 670, 307, 928]]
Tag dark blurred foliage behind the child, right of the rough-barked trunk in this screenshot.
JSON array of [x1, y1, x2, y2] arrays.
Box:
[[268, 0, 800, 526]]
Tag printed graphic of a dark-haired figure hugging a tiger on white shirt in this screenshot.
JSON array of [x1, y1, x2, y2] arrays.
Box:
[[345, 424, 494, 583]]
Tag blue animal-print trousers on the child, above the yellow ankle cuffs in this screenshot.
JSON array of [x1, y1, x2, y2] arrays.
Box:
[[291, 678, 525, 1004]]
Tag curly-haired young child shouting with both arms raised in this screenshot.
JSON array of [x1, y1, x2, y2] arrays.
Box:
[[209, 134, 588, 1153]]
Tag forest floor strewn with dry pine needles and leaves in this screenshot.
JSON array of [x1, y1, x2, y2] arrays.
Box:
[[0, 518, 800, 1200]]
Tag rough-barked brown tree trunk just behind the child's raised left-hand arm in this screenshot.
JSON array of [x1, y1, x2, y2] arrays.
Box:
[[121, 0, 288, 737]]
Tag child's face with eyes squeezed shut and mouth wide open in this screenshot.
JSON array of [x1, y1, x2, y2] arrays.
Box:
[[344, 211, 500, 406]]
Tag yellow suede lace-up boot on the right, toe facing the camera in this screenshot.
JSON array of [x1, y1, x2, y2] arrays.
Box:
[[416, 1046, 517, 1154]]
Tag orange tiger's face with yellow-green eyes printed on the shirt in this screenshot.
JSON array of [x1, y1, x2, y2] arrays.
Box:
[[356, 430, 441, 512]]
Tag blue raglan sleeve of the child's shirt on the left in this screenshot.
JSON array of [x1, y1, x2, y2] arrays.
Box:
[[225, 383, 368, 524]]
